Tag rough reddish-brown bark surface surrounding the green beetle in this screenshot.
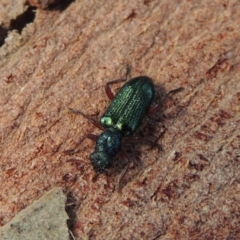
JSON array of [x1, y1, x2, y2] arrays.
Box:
[[0, 0, 240, 240]]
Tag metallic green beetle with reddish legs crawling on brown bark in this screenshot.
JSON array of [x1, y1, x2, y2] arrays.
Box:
[[70, 76, 157, 174]]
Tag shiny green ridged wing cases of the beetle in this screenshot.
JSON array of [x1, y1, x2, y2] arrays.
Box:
[[100, 76, 155, 136]]
